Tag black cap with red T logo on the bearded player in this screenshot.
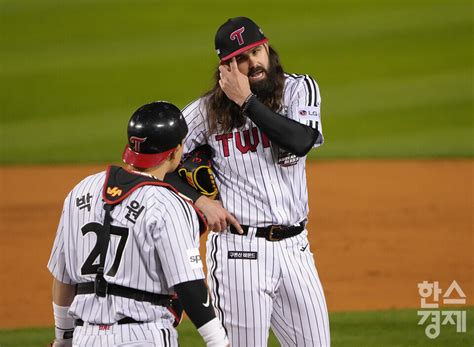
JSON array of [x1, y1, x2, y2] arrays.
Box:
[[215, 17, 268, 61]]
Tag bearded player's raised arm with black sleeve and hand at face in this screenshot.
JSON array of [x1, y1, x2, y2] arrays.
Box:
[[219, 58, 319, 157]]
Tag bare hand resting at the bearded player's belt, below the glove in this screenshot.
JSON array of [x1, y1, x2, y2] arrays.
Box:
[[196, 196, 243, 234]]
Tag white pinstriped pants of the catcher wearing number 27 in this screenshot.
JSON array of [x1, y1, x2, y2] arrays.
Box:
[[72, 322, 178, 347]]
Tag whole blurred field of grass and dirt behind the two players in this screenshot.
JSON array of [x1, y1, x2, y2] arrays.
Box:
[[0, 0, 474, 346]]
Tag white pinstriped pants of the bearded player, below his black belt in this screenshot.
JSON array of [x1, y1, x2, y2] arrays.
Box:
[[206, 228, 330, 347]]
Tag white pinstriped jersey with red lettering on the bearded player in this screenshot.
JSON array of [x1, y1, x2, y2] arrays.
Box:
[[183, 74, 324, 226]]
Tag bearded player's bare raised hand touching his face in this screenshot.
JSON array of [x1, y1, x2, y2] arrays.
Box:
[[219, 57, 252, 106]]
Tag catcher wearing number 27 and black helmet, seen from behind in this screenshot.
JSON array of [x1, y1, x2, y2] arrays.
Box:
[[48, 102, 229, 347]]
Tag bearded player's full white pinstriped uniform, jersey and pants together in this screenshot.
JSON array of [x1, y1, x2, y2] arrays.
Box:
[[183, 74, 330, 347]]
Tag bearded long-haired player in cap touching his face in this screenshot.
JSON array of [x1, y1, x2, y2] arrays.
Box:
[[174, 17, 330, 346]]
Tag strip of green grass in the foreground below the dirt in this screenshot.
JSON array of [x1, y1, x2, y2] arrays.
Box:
[[0, 307, 474, 347]]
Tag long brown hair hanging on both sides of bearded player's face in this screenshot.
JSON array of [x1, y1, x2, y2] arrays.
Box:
[[203, 46, 285, 136]]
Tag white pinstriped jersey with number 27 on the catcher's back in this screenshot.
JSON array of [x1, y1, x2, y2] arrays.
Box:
[[48, 172, 204, 328]]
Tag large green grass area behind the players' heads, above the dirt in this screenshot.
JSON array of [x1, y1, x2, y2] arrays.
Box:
[[0, 0, 474, 164]]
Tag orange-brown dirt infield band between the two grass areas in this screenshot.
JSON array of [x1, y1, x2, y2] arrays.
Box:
[[0, 160, 474, 328]]
